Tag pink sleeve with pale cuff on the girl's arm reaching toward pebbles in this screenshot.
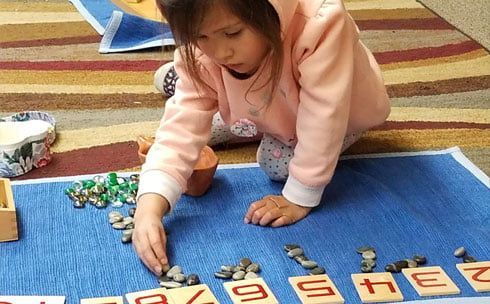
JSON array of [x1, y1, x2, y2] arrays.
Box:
[[138, 50, 218, 211]]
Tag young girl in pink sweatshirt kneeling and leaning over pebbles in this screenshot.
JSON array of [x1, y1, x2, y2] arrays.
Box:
[[133, 0, 390, 275]]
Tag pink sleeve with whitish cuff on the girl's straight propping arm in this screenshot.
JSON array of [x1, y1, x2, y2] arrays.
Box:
[[283, 5, 358, 207]]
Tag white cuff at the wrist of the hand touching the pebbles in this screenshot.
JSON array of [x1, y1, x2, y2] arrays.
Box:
[[136, 170, 182, 212]]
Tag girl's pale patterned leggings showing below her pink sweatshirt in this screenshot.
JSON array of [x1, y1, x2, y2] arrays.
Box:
[[209, 113, 361, 181]]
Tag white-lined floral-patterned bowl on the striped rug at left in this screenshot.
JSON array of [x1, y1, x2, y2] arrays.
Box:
[[0, 111, 56, 177]]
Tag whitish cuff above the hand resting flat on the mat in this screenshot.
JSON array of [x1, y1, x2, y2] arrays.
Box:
[[282, 174, 325, 208]]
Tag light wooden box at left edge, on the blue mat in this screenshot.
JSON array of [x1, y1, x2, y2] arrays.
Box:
[[0, 178, 19, 242]]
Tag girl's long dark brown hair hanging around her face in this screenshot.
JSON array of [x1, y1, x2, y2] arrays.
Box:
[[157, 0, 284, 104]]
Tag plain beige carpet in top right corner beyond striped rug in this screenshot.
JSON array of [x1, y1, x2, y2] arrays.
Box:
[[418, 0, 490, 50]]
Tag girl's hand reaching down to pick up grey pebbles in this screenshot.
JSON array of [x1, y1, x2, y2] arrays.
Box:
[[132, 193, 170, 276]]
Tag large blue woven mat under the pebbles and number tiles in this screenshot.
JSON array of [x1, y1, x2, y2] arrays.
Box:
[[0, 149, 490, 304]]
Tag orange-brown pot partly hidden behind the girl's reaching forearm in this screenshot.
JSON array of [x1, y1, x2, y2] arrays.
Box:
[[136, 136, 218, 196]]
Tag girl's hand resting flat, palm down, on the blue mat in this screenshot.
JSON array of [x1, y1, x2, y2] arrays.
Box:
[[243, 195, 311, 227]]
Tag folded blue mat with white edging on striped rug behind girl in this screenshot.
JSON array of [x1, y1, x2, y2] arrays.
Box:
[[69, 0, 174, 53]]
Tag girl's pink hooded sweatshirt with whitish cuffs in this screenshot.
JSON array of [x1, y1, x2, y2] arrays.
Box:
[[138, 0, 390, 208]]
